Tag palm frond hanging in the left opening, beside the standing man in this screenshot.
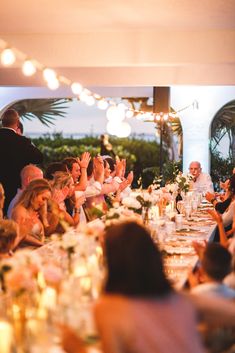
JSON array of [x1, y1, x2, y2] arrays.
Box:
[[9, 98, 70, 126]]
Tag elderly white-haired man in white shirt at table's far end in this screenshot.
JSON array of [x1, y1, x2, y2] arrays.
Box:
[[189, 161, 214, 193]]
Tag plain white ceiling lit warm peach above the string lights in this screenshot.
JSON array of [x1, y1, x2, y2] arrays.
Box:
[[0, 0, 235, 92]]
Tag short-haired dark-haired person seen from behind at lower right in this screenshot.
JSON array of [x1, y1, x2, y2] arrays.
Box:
[[190, 243, 235, 299]]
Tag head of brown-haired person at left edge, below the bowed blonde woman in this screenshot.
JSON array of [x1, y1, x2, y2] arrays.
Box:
[[0, 219, 18, 254]]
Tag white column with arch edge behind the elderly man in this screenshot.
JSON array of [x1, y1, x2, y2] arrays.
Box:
[[171, 86, 235, 173]]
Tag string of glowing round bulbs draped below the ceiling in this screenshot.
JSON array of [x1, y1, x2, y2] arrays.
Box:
[[0, 39, 198, 135]]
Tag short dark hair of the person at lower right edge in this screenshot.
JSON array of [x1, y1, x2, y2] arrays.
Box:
[[202, 243, 232, 281]]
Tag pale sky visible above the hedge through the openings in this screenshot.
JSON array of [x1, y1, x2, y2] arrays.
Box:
[[23, 100, 155, 136]]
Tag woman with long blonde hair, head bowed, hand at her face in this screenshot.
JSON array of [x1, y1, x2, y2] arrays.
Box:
[[12, 179, 51, 246]]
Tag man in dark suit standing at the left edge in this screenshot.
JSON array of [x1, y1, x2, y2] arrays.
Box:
[[0, 109, 43, 215]]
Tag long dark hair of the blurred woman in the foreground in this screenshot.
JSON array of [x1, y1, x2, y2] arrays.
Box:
[[104, 222, 173, 297]]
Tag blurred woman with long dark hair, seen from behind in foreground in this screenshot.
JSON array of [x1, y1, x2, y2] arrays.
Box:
[[63, 222, 204, 353]]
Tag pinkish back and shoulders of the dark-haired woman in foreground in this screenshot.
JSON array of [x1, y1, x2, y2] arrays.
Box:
[[95, 294, 204, 353]]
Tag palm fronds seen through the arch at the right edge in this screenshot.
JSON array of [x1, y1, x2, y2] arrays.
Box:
[[210, 100, 235, 164]]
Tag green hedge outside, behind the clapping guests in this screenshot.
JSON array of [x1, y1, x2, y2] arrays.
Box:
[[33, 134, 163, 187]]
